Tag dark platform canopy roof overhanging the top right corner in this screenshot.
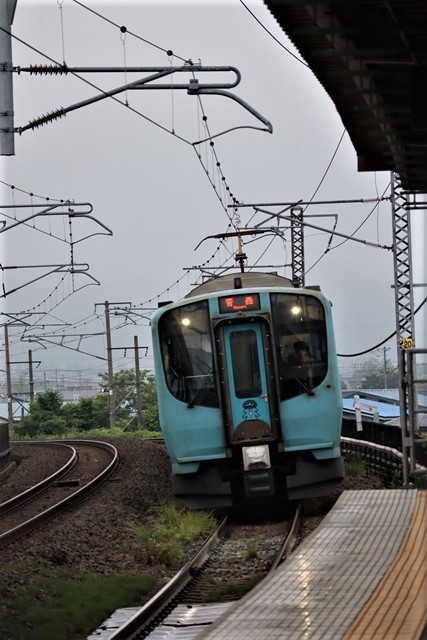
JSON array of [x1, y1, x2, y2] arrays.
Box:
[[264, 0, 427, 193]]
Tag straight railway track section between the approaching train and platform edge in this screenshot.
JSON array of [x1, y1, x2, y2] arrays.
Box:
[[90, 507, 302, 640]]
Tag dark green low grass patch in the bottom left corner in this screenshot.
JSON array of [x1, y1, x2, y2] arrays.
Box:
[[0, 562, 156, 640]]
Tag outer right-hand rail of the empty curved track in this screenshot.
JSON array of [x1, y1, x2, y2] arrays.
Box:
[[0, 440, 119, 548]]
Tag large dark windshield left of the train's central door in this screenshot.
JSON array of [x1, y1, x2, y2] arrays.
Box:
[[159, 301, 218, 407]]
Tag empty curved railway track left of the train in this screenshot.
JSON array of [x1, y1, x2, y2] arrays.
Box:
[[0, 440, 119, 548]]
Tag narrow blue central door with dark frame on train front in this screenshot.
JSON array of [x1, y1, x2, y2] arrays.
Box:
[[219, 321, 277, 443]]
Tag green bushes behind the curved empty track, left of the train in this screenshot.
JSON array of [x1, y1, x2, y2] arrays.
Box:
[[14, 370, 160, 438]]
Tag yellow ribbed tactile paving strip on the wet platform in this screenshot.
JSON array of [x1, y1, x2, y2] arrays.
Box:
[[344, 491, 427, 640]]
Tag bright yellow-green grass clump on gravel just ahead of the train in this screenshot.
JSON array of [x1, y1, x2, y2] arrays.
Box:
[[132, 503, 216, 566]]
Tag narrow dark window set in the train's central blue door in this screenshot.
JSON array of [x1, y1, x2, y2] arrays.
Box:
[[230, 331, 262, 398]]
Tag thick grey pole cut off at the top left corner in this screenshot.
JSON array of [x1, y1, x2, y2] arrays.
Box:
[[0, 0, 17, 156]]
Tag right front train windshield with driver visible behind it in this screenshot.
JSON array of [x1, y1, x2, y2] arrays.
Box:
[[271, 293, 328, 400]]
